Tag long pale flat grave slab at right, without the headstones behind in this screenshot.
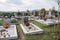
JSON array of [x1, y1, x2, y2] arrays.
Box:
[[35, 19, 60, 25]]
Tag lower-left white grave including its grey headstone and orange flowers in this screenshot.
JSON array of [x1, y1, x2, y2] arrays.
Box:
[[0, 16, 17, 40]]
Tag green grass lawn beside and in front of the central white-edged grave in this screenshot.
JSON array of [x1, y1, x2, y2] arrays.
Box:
[[19, 20, 60, 40]]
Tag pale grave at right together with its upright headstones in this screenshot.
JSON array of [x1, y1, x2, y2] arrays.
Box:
[[35, 10, 60, 25]]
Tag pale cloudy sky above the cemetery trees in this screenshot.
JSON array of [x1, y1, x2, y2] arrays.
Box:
[[0, 0, 58, 11]]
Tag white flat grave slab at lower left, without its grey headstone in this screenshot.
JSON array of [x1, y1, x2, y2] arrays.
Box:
[[0, 25, 18, 40]]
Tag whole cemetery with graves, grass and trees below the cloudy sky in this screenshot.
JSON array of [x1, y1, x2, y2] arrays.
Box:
[[0, 0, 60, 40]]
